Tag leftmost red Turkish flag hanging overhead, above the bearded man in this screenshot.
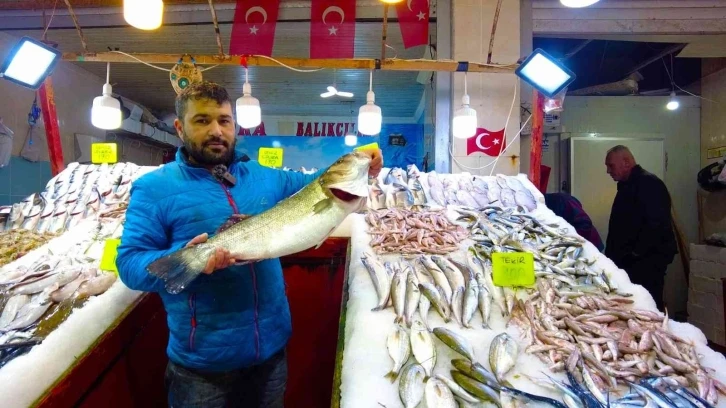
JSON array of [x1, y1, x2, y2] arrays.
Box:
[[229, 0, 280, 57]]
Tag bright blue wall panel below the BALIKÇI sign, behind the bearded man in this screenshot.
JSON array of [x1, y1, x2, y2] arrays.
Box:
[[237, 124, 424, 169]]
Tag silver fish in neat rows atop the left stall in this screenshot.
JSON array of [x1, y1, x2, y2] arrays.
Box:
[[0, 163, 139, 234]]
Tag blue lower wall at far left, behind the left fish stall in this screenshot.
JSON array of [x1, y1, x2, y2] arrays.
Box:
[[0, 156, 52, 205]]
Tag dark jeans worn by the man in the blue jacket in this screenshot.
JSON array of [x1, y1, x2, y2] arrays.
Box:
[[164, 349, 287, 408]]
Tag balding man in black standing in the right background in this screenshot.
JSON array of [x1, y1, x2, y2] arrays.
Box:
[[605, 145, 678, 310]]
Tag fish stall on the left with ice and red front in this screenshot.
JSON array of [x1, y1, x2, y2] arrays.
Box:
[[0, 163, 169, 407]]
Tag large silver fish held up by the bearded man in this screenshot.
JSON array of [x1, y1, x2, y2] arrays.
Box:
[[147, 151, 371, 294]]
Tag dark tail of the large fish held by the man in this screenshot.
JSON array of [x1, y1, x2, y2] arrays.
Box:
[[146, 244, 215, 294]]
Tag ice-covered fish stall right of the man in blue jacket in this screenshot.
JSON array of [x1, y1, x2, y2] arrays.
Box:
[[332, 169, 726, 408]]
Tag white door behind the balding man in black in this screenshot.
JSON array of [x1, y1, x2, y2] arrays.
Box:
[[569, 137, 665, 245]]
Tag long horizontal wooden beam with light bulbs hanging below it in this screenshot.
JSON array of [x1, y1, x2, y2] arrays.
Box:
[[63, 52, 517, 74]]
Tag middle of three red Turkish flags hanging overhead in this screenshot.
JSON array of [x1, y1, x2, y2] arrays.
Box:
[[310, 0, 355, 58]]
